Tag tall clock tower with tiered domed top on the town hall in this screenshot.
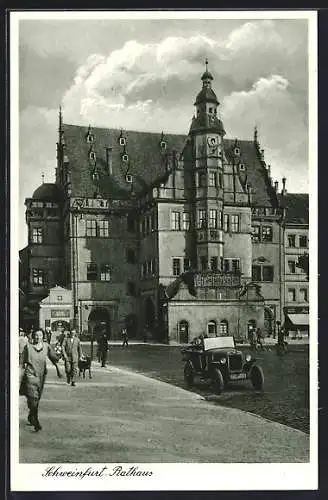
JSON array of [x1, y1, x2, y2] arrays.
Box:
[[189, 60, 225, 272]]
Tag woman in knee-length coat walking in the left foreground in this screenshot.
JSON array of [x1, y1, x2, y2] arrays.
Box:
[[19, 329, 62, 432]]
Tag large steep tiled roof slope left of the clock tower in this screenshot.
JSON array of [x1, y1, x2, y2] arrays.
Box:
[[63, 124, 186, 199]]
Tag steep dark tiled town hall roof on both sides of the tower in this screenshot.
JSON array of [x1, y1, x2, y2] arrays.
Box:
[[63, 124, 277, 206]]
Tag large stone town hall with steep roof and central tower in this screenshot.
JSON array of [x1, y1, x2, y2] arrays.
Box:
[[20, 65, 306, 342]]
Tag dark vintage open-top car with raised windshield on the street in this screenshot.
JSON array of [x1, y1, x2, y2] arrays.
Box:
[[181, 337, 264, 394]]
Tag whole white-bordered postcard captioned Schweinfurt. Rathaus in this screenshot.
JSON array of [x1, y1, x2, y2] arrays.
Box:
[[10, 11, 318, 491]]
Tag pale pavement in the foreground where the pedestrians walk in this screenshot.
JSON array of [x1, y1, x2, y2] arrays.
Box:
[[20, 363, 309, 463]]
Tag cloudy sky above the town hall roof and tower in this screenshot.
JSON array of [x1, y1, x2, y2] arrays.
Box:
[[19, 19, 308, 247]]
